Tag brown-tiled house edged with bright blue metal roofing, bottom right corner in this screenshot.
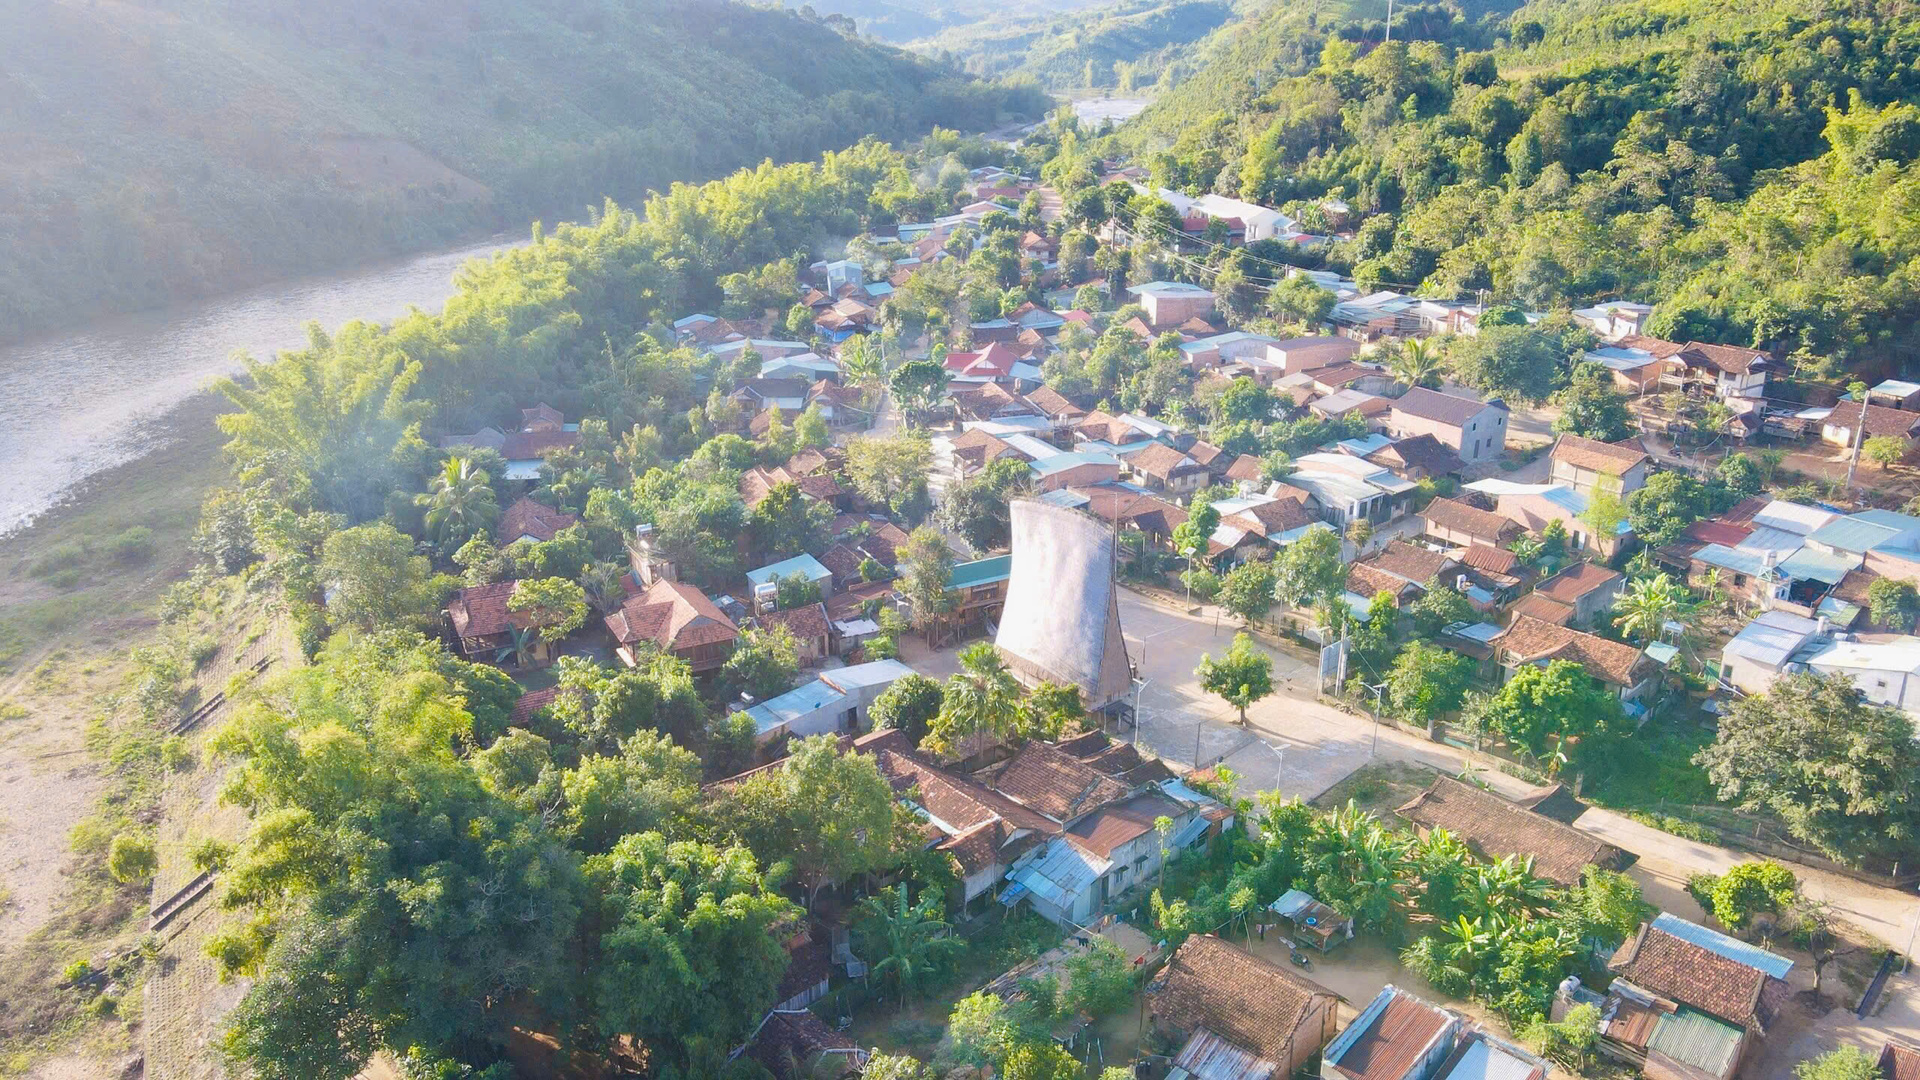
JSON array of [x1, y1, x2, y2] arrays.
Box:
[[1597, 915, 1793, 1080]]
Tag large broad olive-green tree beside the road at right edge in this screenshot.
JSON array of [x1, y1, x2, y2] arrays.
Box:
[[1693, 673, 1920, 861]]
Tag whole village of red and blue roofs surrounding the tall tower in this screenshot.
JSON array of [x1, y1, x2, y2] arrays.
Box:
[[153, 151, 1920, 1080]]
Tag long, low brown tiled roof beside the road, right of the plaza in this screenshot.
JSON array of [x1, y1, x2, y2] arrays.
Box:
[[1400, 776, 1624, 886]]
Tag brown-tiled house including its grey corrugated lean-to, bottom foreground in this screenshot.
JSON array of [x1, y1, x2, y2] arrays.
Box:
[[1146, 934, 1340, 1078]]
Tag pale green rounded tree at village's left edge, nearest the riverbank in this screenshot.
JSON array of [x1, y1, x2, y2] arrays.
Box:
[[319, 521, 444, 632]]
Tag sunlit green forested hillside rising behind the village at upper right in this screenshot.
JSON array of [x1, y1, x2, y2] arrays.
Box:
[[1127, 0, 1920, 369]]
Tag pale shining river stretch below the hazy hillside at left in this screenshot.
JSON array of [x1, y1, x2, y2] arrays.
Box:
[[0, 238, 509, 536]]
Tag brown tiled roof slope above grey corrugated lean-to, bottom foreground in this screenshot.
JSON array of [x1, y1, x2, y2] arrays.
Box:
[[1150, 934, 1340, 1063]]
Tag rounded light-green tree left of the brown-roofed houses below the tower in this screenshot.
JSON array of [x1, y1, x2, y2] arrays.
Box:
[[732, 734, 895, 896]]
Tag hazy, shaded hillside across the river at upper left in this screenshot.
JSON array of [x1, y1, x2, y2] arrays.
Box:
[[0, 0, 1044, 338]]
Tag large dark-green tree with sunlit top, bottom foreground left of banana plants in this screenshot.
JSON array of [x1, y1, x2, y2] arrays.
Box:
[[586, 832, 797, 1063]]
